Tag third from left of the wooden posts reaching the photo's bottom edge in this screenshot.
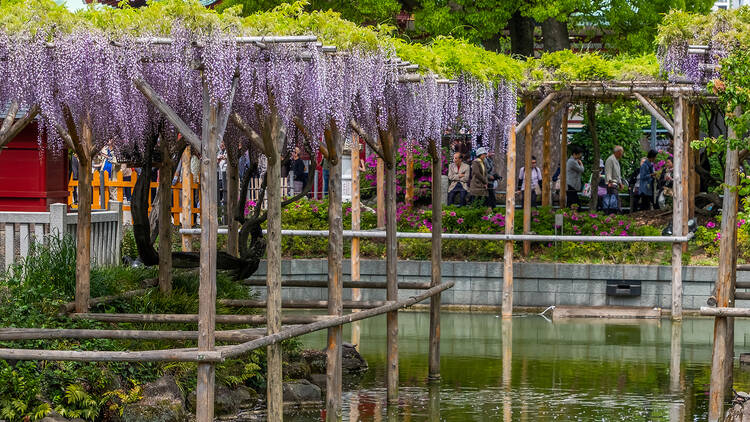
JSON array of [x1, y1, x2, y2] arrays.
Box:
[[325, 123, 344, 422]]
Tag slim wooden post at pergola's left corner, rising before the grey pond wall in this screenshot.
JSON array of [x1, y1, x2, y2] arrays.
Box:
[[502, 127, 516, 318]]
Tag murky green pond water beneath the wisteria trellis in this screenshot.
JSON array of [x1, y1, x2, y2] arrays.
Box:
[[285, 312, 750, 421]]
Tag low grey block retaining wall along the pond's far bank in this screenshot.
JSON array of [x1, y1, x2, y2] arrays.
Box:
[[253, 259, 736, 309]]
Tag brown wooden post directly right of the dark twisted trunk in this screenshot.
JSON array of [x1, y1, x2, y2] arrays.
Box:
[[159, 140, 175, 293]]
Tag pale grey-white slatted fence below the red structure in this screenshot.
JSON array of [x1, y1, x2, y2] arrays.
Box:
[[0, 201, 123, 269]]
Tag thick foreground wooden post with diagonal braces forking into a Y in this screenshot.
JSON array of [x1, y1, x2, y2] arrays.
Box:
[[196, 92, 219, 422]]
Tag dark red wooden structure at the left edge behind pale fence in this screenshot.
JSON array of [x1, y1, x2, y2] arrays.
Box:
[[0, 123, 68, 212]]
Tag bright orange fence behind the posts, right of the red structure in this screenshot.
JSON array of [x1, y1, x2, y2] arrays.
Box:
[[68, 171, 200, 225]]
